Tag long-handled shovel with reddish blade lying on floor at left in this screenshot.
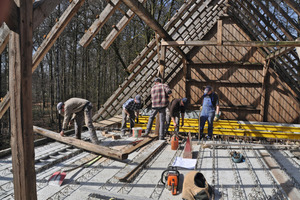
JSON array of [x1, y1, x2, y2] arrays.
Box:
[[48, 156, 102, 186]]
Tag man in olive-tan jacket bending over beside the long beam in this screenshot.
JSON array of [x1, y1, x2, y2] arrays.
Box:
[[57, 98, 98, 144]]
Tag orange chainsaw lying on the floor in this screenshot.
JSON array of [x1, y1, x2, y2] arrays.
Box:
[[160, 166, 180, 195]]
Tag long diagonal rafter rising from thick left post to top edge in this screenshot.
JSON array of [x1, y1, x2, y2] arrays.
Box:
[[32, 0, 84, 72]]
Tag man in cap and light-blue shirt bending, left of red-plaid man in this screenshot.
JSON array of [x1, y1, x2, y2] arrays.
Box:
[[121, 95, 142, 135]]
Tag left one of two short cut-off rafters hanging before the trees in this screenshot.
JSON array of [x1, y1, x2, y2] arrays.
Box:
[[79, 0, 121, 47]]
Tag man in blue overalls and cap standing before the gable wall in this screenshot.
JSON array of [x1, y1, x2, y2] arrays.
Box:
[[199, 85, 220, 140]]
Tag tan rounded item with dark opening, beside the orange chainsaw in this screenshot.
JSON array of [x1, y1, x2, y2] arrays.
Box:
[[182, 171, 212, 200]]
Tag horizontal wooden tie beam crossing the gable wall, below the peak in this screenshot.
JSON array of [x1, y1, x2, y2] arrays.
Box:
[[161, 40, 300, 47]]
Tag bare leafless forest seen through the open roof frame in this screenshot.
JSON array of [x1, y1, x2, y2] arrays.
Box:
[[0, 0, 183, 149]]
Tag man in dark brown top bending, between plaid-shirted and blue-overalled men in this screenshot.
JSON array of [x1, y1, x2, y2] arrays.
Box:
[[166, 98, 188, 133]]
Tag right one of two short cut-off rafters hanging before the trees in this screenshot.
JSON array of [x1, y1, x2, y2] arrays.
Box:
[[101, 0, 146, 49]]
